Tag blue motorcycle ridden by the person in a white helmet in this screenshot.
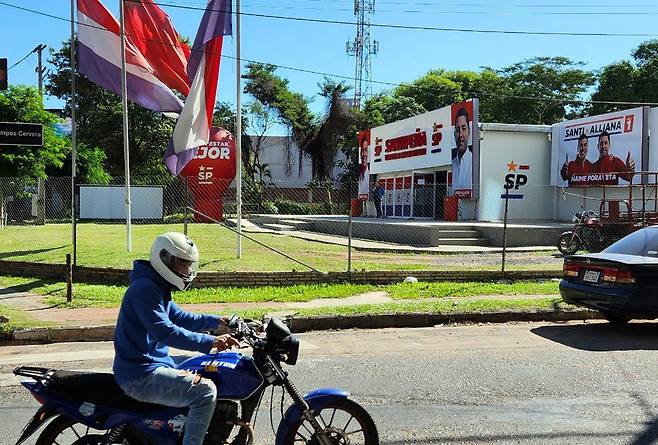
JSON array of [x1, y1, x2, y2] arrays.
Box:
[[14, 316, 379, 445]]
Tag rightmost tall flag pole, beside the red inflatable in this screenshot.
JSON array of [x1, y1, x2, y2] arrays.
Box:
[[235, 0, 242, 259]]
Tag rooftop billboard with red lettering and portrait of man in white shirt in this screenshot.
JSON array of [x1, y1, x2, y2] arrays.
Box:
[[369, 99, 480, 198]]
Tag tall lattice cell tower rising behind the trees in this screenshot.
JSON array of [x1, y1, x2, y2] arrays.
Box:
[[347, 0, 379, 108]]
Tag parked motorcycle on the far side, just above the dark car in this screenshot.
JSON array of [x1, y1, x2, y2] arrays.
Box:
[[557, 210, 610, 255]]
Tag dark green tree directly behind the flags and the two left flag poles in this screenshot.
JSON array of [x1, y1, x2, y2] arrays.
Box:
[[46, 41, 175, 183]]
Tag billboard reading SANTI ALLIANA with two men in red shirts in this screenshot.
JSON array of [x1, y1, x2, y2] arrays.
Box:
[[551, 107, 646, 187]]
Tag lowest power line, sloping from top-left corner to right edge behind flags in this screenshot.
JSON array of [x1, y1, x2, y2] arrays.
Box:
[[0, 0, 658, 106]]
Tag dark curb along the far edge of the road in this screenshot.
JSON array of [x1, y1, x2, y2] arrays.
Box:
[[13, 309, 603, 344]]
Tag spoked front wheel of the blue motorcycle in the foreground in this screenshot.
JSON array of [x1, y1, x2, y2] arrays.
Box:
[[284, 399, 379, 445]]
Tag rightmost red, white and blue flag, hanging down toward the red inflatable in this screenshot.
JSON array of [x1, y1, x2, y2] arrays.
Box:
[[164, 0, 232, 175]]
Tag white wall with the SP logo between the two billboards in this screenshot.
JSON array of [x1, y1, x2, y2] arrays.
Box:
[[474, 124, 555, 221]]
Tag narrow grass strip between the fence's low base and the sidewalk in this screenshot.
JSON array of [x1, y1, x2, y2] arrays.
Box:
[[0, 276, 559, 308]]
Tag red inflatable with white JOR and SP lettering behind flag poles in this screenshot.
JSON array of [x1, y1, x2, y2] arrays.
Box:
[[181, 128, 237, 222]]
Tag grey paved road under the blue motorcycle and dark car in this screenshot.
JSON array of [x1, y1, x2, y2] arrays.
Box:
[[0, 322, 658, 445]]
